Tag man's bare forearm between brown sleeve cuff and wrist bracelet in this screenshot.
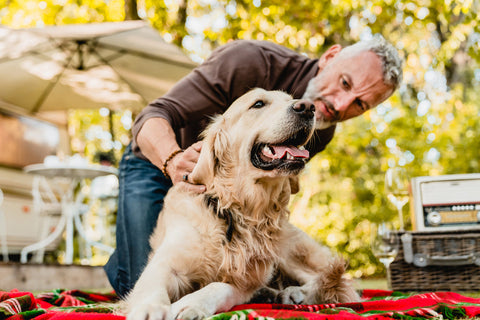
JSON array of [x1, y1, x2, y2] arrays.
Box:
[[137, 118, 180, 169]]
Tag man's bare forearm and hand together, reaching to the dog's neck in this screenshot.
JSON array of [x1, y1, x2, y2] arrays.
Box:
[[137, 118, 205, 193]]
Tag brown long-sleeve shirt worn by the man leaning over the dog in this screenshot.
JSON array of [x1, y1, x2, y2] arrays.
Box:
[[132, 40, 335, 159]]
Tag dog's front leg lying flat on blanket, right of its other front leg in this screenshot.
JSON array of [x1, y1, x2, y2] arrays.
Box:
[[171, 282, 252, 320]]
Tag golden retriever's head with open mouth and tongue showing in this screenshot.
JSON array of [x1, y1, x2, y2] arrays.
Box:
[[191, 89, 315, 188]]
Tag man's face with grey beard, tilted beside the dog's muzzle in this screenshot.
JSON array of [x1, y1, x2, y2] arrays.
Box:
[[303, 51, 393, 129]]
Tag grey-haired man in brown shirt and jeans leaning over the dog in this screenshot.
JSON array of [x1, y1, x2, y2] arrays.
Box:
[[105, 37, 402, 296]]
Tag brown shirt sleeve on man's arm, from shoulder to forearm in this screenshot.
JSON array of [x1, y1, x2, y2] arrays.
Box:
[[132, 40, 268, 155]]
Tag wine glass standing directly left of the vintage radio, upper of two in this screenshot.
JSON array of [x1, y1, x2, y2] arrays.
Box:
[[385, 167, 408, 231]]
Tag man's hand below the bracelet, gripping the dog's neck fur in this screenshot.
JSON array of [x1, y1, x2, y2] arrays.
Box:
[[167, 141, 206, 193]]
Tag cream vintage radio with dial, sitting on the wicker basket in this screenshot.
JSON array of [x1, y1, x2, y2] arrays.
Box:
[[411, 173, 480, 231]]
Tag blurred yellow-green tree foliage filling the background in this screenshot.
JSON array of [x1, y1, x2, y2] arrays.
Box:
[[0, 0, 480, 278]]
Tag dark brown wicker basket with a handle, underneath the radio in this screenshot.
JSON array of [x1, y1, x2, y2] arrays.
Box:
[[390, 231, 480, 291]]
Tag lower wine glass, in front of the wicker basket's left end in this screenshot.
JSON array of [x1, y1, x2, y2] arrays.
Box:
[[371, 222, 399, 288]]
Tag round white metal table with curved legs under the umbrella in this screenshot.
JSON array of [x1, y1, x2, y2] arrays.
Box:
[[20, 163, 118, 264]]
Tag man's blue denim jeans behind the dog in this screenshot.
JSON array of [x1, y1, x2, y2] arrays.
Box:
[[104, 145, 172, 297]]
